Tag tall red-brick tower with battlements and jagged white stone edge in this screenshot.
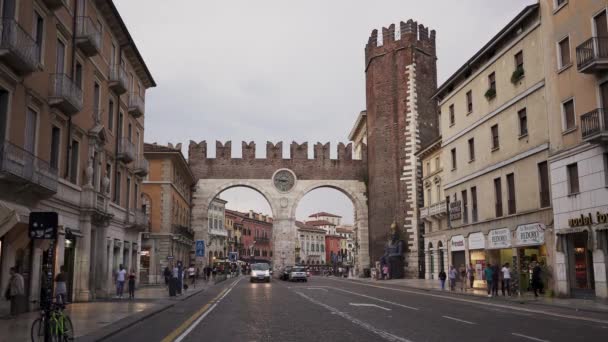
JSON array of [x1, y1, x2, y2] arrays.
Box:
[[365, 19, 439, 278]]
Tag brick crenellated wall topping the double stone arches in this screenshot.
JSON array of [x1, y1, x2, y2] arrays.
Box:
[[188, 141, 367, 181]]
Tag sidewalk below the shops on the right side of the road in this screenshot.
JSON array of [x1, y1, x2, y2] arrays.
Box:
[[349, 278, 608, 313]]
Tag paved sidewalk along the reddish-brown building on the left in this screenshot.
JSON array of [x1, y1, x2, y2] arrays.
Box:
[[0, 281, 213, 342]]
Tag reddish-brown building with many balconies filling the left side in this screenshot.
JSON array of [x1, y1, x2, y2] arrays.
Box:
[[0, 0, 155, 312]]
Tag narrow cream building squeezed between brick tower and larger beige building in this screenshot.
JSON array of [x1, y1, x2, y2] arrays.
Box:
[[416, 137, 449, 279]]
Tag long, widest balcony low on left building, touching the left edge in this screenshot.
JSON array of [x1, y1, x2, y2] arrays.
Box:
[[0, 141, 57, 196]]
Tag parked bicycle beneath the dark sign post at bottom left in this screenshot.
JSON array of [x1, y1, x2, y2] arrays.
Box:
[[31, 303, 74, 342]]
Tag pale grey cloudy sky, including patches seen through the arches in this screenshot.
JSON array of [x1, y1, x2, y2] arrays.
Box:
[[114, 0, 536, 222]]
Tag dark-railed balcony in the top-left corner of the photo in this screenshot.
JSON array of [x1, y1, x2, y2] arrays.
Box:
[[0, 19, 40, 75]]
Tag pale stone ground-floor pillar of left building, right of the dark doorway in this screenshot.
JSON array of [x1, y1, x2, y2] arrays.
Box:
[[73, 215, 92, 302]]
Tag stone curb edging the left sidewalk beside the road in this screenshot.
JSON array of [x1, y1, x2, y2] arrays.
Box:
[[76, 287, 208, 342]]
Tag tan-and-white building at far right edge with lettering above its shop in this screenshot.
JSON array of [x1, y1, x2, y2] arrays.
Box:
[[540, 0, 608, 298]]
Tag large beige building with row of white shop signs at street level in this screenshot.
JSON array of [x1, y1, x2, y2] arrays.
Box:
[[431, 4, 554, 291]]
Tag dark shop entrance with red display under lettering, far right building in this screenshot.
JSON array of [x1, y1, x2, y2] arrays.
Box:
[[568, 232, 595, 298]]
